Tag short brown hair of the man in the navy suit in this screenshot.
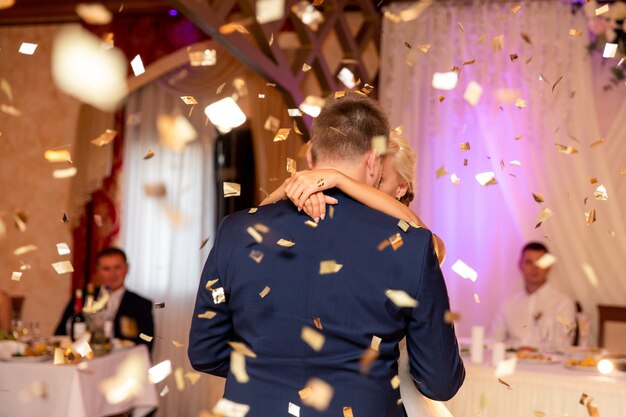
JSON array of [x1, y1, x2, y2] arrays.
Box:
[[311, 91, 389, 164]]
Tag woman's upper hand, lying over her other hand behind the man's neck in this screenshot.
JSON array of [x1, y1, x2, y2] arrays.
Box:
[[285, 169, 341, 210]]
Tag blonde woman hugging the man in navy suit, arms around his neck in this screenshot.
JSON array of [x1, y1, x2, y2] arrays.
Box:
[[261, 131, 452, 417]]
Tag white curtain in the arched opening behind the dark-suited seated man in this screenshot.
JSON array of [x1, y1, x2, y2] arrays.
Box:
[[121, 82, 222, 416]]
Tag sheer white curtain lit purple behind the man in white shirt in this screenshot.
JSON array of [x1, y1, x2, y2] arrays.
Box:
[[380, 0, 626, 342]]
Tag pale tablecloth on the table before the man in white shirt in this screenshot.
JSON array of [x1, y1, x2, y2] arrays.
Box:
[[446, 358, 626, 417]]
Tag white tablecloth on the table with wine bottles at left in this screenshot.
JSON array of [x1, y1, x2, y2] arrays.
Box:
[[0, 346, 158, 417]]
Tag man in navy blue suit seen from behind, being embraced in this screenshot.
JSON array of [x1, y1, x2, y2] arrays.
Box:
[[188, 93, 465, 417]]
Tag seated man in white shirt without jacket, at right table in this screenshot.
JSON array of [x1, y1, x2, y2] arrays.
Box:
[[491, 242, 576, 348]]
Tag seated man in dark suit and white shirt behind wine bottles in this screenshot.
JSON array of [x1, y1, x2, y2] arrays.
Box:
[[55, 247, 154, 350]]
